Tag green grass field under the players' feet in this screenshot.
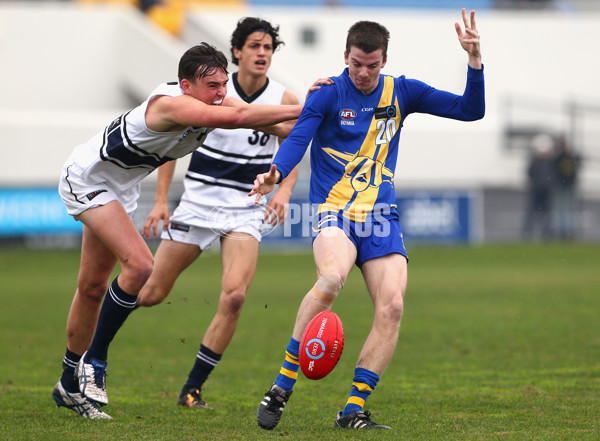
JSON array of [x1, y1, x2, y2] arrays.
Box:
[[0, 244, 600, 441]]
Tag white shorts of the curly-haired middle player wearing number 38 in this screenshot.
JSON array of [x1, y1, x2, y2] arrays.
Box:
[[161, 206, 264, 251]]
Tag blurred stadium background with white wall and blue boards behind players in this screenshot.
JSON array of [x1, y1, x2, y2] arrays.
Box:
[[0, 0, 600, 247]]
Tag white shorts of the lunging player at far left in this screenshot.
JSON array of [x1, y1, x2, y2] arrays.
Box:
[[58, 164, 141, 216]]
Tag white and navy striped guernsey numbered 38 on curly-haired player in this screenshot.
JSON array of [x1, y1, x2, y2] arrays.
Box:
[[174, 73, 285, 220]]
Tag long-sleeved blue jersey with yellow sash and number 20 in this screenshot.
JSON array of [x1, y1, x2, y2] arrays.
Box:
[[273, 67, 485, 222]]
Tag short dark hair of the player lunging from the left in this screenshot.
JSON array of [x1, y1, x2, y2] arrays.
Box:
[[178, 42, 228, 83]]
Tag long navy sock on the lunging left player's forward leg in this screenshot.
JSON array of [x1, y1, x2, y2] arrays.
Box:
[[85, 277, 137, 362]]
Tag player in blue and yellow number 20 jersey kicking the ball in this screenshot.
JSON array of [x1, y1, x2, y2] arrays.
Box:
[[250, 9, 485, 430]]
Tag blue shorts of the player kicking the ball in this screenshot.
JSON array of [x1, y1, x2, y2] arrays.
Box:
[[312, 211, 408, 268]]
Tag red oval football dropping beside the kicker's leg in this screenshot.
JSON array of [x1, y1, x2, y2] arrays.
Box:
[[300, 311, 344, 380]]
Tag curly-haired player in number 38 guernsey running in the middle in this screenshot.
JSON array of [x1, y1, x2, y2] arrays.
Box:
[[138, 17, 298, 407]]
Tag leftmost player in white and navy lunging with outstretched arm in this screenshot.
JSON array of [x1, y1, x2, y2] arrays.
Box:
[[52, 43, 310, 419]]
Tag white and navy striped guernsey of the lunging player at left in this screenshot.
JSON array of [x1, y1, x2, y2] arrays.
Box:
[[65, 82, 213, 192]]
